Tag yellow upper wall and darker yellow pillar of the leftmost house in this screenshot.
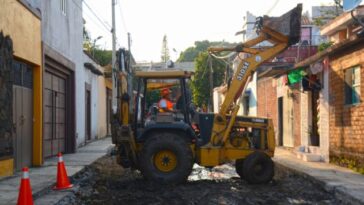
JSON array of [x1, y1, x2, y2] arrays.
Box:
[[0, 0, 43, 172]]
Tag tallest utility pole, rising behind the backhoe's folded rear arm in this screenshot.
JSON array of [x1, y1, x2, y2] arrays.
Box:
[[111, 0, 118, 114]]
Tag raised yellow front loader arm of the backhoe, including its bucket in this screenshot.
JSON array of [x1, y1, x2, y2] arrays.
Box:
[[208, 4, 302, 146]]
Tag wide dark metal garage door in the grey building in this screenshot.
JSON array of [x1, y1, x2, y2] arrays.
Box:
[[43, 72, 66, 157]]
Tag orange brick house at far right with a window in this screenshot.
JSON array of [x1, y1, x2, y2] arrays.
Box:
[[295, 7, 364, 163]]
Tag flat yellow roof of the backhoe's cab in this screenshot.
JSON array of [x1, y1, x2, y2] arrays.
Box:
[[135, 70, 193, 79]]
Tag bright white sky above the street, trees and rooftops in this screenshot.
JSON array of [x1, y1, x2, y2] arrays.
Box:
[[83, 0, 334, 62]]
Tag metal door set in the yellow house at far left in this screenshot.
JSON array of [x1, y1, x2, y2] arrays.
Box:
[[13, 61, 33, 170]]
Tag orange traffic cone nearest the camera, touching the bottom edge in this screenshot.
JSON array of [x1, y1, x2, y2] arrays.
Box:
[[17, 167, 33, 205]]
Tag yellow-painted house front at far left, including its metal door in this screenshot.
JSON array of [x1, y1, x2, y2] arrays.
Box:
[[0, 0, 43, 177]]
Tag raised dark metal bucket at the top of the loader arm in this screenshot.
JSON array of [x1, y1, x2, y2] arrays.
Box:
[[263, 4, 302, 45]]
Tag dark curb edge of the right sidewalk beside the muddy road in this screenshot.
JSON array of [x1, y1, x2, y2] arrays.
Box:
[[274, 161, 364, 205]]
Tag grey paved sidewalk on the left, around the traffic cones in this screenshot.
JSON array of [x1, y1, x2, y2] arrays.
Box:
[[0, 137, 113, 205]]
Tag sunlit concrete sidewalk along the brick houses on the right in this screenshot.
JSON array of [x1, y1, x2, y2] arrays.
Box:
[[273, 148, 364, 204]]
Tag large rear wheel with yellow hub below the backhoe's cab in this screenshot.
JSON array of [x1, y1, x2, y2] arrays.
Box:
[[140, 132, 194, 184]]
